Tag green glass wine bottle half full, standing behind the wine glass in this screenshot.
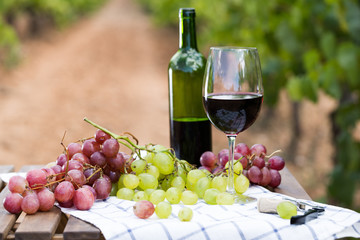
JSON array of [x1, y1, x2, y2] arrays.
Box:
[[168, 8, 211, 166]]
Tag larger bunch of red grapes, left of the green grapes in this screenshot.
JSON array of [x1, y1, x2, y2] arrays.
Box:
[[4, 130, 130, 214]]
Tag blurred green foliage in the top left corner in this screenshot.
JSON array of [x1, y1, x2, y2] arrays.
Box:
[[0, 0, 105, 66]]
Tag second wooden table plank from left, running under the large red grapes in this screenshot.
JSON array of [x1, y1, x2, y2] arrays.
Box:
[[15, 165, 61, 239]]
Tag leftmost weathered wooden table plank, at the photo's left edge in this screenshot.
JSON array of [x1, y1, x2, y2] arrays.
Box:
[[0, 165, 16, 239]]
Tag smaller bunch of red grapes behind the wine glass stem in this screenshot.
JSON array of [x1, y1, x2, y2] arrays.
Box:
[[200, 143, 285, 188]]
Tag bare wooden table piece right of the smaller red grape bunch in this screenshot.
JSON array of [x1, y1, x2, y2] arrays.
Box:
[[275, 167, 311, 200]]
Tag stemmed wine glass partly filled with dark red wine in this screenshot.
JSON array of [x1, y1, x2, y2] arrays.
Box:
[[202, 47, 263, 203]]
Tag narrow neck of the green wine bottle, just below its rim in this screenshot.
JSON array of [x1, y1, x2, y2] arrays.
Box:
[[179, 17, 197, 50]]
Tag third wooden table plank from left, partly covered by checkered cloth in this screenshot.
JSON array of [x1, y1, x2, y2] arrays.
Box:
[[64, 216, 103, 240]]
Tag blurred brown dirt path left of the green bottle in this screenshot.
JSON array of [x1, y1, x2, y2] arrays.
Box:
[[0, 0, 177, 170]]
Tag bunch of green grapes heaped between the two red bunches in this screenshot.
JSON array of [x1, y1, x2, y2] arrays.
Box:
[[112, 149, 249, 205]]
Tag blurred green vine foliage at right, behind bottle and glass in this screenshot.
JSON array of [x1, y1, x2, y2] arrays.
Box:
[[138, 0, 360, 207]]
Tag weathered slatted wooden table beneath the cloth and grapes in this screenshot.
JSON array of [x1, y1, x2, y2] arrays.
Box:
[[0, 165, 311, 240]]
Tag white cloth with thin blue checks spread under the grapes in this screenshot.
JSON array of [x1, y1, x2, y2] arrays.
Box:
[[61, 186, 360, 240]]
